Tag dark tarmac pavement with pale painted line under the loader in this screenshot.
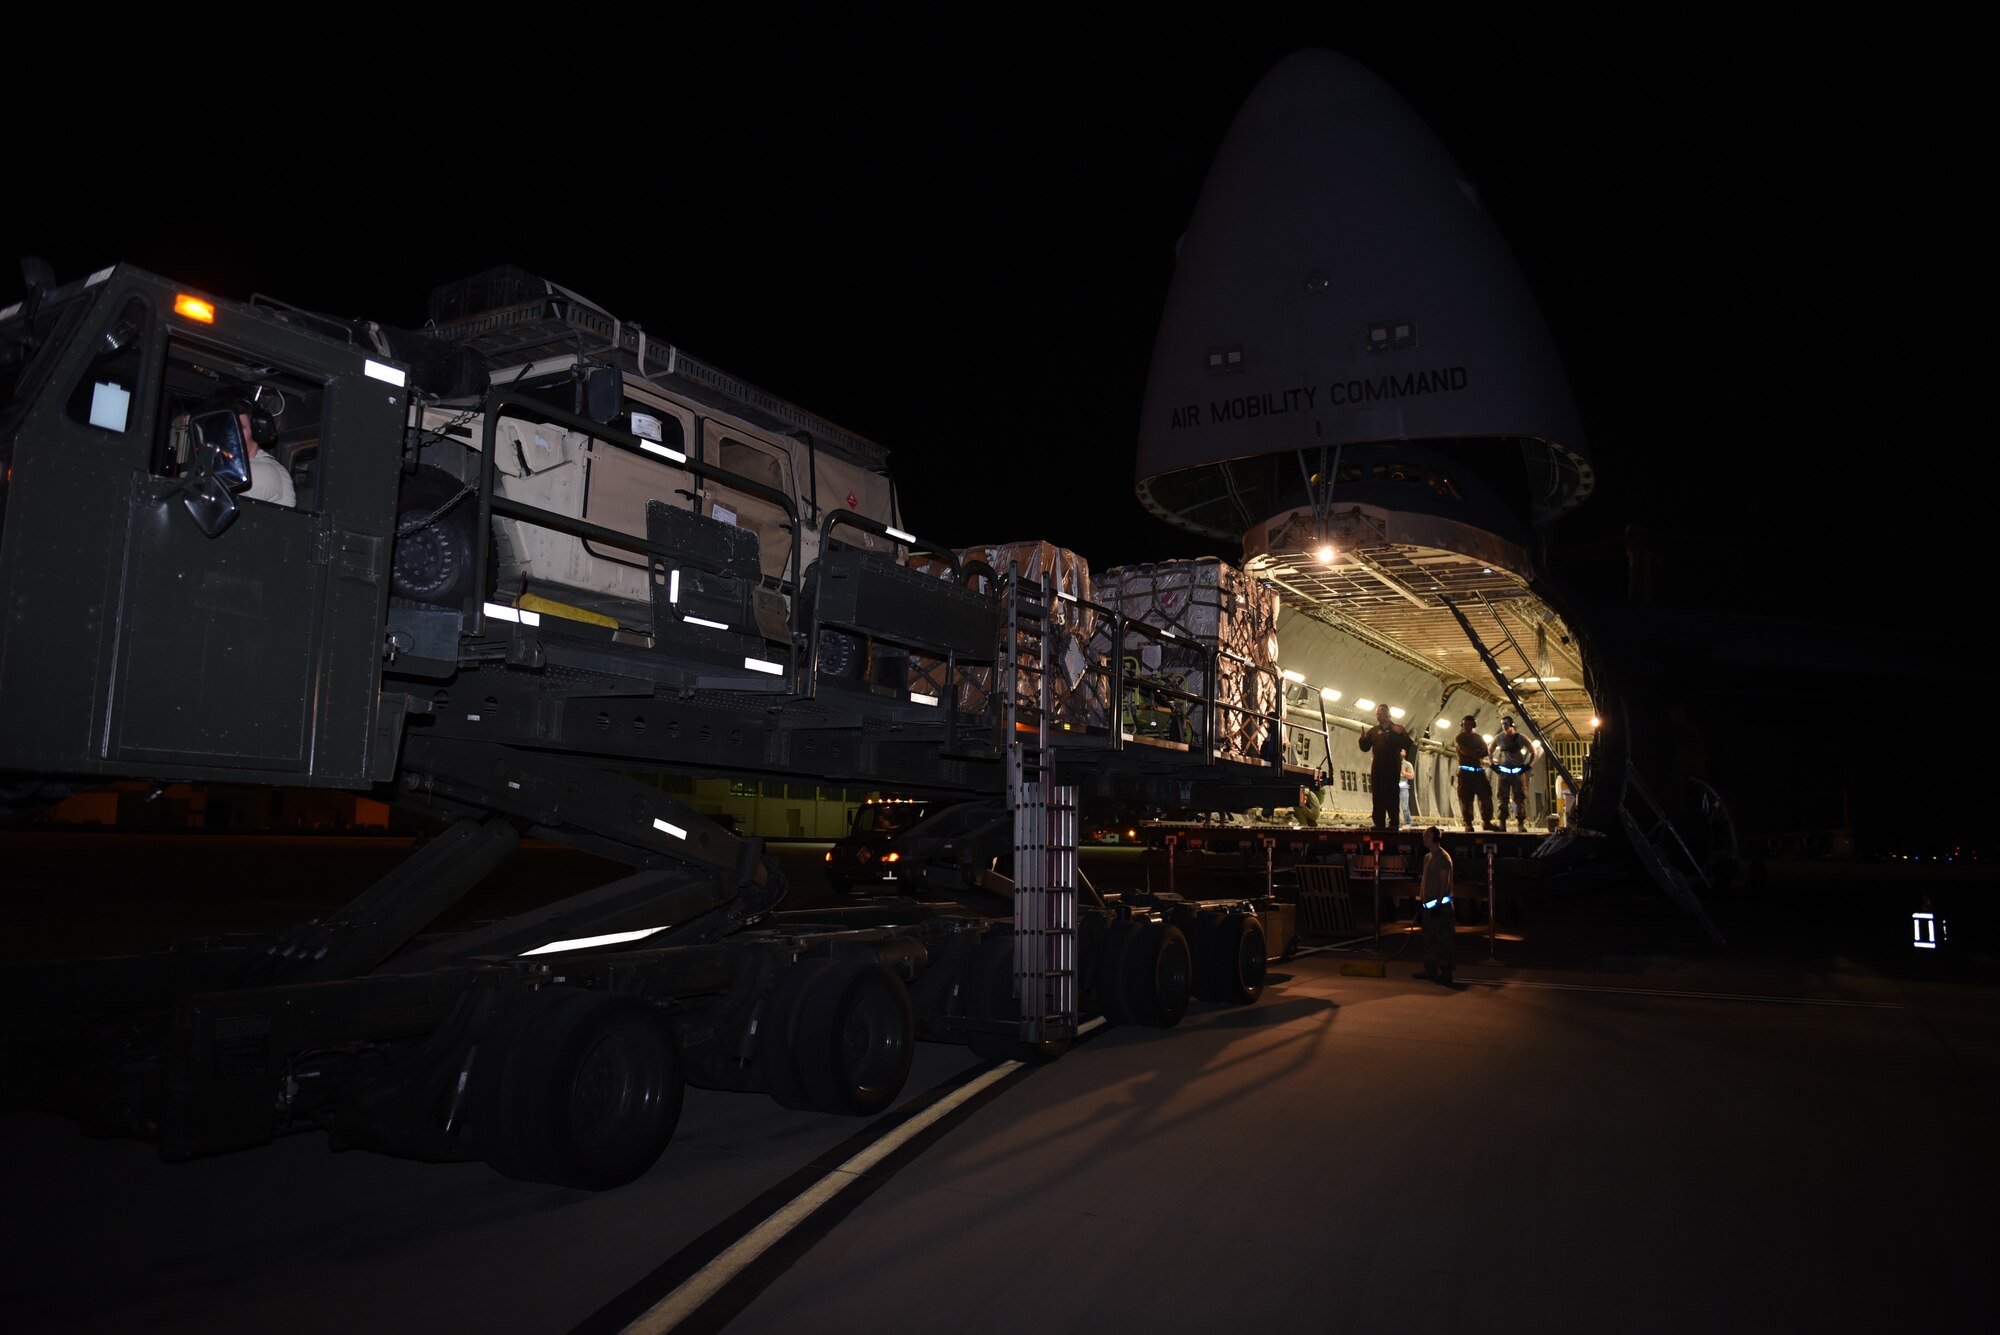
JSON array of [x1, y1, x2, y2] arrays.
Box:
[[0, 827, 2000, 1335]]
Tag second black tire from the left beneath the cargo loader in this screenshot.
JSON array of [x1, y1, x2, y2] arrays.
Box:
[[794, 959, 916, 1117]]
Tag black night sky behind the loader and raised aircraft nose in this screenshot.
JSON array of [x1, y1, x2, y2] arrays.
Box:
[[0, 6, 1992, 839]]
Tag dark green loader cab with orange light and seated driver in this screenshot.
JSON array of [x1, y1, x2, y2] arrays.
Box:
[[0, 266, 406, 785]]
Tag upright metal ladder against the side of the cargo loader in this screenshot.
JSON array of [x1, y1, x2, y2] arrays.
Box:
[[998, 566, 1078, 1043]]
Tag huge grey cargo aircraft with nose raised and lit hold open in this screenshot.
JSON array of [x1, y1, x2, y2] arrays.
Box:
[[1138, 50, 1730, 935]]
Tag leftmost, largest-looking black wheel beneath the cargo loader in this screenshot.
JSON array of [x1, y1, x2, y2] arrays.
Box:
[[474, 987, 682, 1191]]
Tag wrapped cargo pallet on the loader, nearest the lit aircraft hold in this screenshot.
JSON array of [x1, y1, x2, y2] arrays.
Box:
[[1096, 558, 1278, 759]]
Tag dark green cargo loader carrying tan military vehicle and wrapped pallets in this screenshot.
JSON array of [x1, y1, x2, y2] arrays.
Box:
[[0, 262, 1324, 1189]]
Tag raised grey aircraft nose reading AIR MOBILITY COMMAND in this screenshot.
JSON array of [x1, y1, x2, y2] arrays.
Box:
[[1138, 50, 1590, 528]]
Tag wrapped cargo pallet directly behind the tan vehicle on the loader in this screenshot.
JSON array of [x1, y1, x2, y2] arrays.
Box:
[[910, 542, 1110, 727]]
